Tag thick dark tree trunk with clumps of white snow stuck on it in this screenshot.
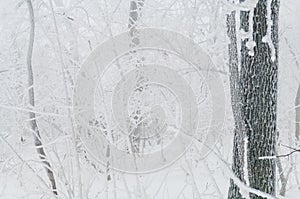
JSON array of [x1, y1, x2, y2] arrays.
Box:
[[228, 0, 279, 199]]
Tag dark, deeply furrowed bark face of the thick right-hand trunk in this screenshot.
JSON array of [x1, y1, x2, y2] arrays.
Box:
[[241, 0, 279, 199]]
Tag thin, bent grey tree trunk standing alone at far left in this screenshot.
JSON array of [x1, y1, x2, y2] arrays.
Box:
[[27, 0, 57, 195]]
